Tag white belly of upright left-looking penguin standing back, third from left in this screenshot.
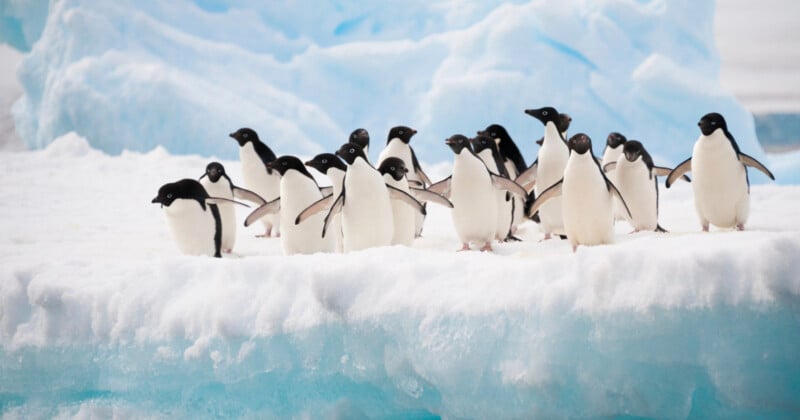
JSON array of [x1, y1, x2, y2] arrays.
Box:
[[239, 143, 281, 234]]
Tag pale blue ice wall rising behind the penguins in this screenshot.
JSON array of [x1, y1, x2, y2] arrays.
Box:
[[0, 0, 776, 181]]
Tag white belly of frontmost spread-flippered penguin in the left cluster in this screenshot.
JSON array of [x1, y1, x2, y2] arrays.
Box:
[[342, 159, 394, 252]]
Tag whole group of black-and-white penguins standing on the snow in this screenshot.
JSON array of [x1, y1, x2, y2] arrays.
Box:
[[152, 107, 775, 257]]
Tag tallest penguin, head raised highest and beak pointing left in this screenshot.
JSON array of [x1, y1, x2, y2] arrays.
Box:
[[516, 107, 570, 240]]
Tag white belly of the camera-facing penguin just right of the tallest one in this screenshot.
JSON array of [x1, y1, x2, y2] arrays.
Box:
[[561, 153, 614, 247]]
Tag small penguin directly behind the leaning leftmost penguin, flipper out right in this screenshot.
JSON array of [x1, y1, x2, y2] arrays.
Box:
[[200, 162, 266, 254]]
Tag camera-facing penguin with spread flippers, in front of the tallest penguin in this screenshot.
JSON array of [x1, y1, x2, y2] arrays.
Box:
[[530, 133, 630, 252]]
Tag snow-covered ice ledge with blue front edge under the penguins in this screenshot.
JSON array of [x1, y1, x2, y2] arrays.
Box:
[[0, 135, 800, 418]]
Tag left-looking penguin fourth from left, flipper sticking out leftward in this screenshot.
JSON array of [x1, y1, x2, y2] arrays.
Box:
[[245, 155, 336, 255]]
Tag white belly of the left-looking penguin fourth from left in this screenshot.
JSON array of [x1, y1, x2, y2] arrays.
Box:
[[280, 170, 335, 255]]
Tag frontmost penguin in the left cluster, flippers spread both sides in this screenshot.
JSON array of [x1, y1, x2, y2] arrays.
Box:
[[295, 143, 425, 252]]
